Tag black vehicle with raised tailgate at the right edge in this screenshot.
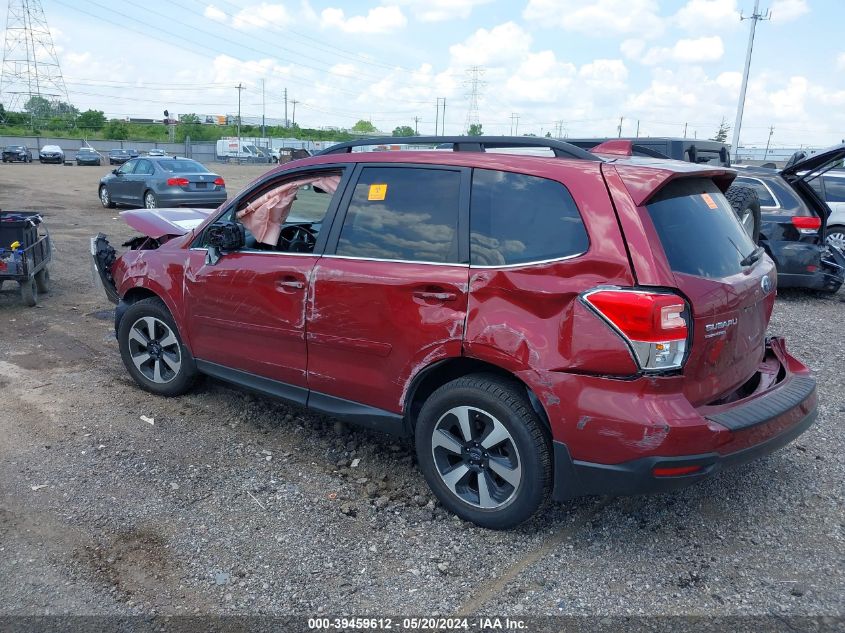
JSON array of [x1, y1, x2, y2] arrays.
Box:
[[734, 144, 845, 292]]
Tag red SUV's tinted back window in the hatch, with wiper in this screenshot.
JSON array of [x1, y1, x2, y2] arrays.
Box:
[[646, 178, 754, 278]]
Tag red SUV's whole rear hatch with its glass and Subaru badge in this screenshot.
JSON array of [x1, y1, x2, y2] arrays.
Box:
[[644, 177, 777, 405]]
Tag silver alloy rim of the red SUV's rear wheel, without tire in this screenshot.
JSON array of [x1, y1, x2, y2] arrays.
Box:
[[431, 406, 522, 510]]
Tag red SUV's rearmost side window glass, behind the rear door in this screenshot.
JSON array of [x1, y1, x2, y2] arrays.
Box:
[[470, 169, 589, 266]]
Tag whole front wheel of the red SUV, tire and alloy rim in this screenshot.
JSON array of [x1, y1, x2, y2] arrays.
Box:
[[117, 297, 197, 396]]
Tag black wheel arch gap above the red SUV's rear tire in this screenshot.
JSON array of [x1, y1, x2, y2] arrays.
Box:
[[402, 356, 552, 440]]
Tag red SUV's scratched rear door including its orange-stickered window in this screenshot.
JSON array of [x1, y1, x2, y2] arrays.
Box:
[[308, 164, 469, 412]]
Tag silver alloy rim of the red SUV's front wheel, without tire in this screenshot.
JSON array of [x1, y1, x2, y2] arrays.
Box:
[[129, 316, 182, 384]]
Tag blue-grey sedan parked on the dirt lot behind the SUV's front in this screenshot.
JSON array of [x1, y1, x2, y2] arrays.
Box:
[[97, 156, 226, 209]]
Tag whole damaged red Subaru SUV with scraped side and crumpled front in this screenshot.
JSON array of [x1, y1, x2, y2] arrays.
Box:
[[92, 137, 817, 528]]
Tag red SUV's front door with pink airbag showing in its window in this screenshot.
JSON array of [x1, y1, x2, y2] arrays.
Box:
[[185, 170, 340, 396]]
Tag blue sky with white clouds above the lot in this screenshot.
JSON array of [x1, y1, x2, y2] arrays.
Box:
[[3, 0, 845, 146]]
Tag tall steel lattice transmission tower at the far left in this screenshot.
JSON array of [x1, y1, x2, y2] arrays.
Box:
[[0, 0, 68, 110]]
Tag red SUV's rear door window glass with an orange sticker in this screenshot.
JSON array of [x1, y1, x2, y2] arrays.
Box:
[[337, 167, 461, 264]]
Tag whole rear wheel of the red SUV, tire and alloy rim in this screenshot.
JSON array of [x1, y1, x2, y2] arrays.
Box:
[[415, 374, 552, 530]]
